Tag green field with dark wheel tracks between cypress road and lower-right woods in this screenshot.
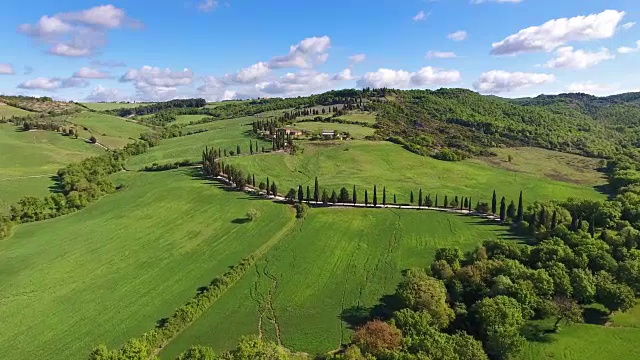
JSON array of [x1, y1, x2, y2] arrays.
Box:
[[161, 208, 506, 359]]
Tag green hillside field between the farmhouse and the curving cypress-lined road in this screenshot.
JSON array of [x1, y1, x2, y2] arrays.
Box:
[[229, 140, 605, 204]]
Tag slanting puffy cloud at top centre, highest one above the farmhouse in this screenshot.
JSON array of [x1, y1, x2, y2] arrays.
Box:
[[269, 36, 331, 69]]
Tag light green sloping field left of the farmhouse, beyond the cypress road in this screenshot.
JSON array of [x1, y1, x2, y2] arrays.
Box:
[[127, 118, 271, 169]]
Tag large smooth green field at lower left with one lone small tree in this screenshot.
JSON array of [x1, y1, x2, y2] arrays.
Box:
[[0, 169, 294, 360]]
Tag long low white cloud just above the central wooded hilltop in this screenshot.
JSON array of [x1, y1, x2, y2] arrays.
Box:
[[358, 66, 460, 89]]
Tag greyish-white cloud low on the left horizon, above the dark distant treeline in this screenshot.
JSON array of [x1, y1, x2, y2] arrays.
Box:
[[120, 65, 193, 101]]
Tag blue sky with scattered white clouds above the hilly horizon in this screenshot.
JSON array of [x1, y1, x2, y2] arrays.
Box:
[[0, 0, 640, 101]]
